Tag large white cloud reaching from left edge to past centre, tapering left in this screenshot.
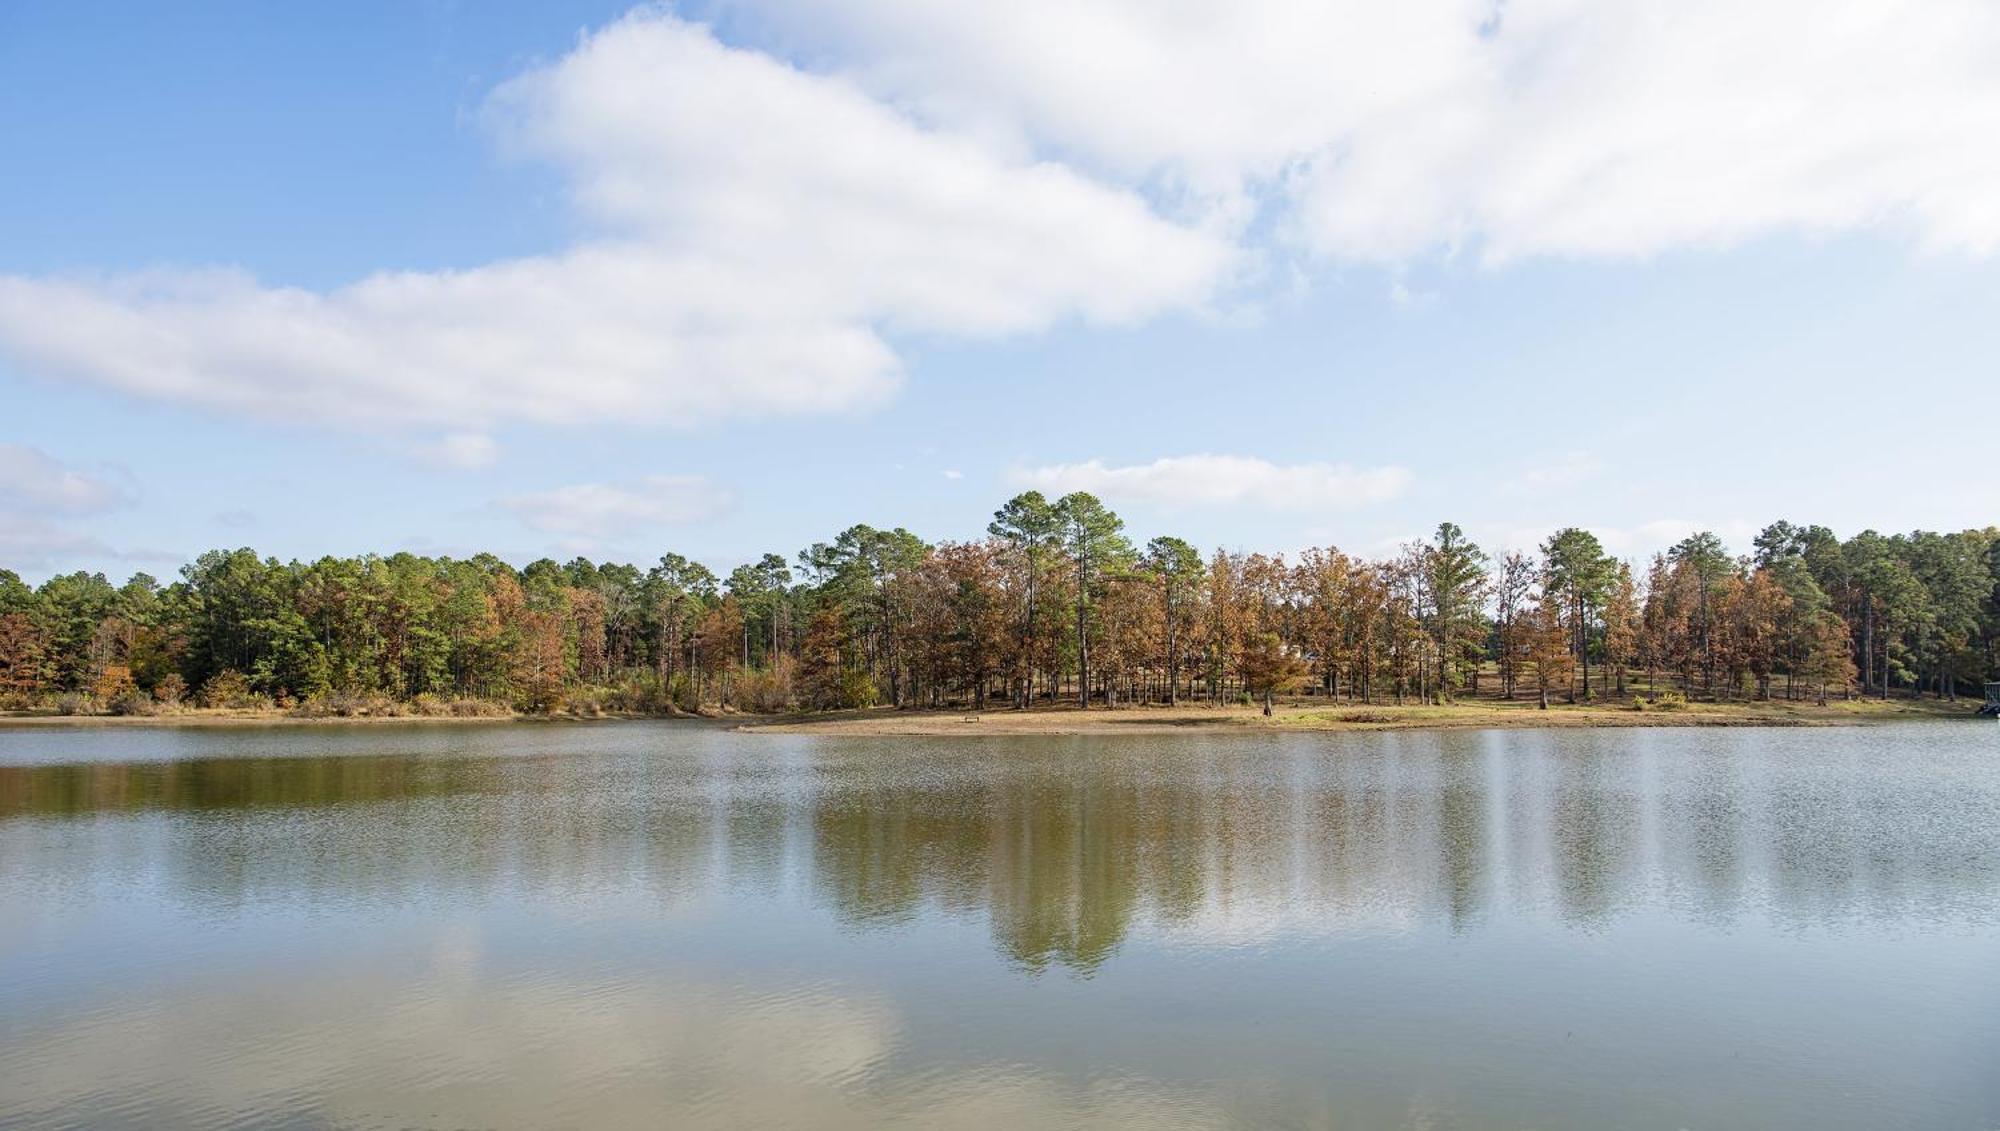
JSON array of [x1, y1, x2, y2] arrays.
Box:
[[0, 10, 1234, 430]]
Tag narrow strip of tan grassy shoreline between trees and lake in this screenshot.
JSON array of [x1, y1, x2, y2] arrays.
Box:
[[0, 699, 1980, 737]]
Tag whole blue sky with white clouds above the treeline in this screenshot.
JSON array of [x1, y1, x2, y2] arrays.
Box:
[[0, 0, 2000, 579]]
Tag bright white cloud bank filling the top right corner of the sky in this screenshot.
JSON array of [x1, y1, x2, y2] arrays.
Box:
[[738, 0, 2000, 262]]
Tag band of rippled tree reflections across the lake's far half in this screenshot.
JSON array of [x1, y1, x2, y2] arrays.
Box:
[[0, 727, 2000, 975]]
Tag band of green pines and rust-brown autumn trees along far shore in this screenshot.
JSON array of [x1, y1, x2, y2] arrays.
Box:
[[0, 492, 2000, 715]]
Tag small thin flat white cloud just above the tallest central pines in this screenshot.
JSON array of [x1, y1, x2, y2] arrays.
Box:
[[1012, 454, 1410, 510]]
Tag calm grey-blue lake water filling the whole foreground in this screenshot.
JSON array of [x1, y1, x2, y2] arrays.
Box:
[[0, 721, 2000, 1129]]
